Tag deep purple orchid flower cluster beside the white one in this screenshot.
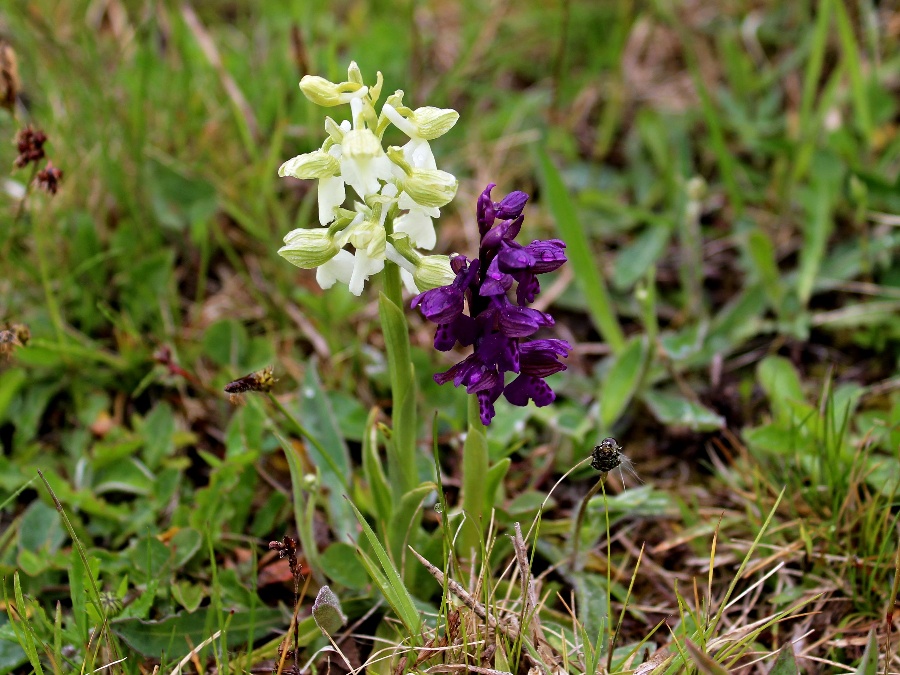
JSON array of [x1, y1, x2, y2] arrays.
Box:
[[412, 183, 572, 424]]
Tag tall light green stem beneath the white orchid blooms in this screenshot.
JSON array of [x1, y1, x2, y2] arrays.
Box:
[[378, 261, 418, 496]]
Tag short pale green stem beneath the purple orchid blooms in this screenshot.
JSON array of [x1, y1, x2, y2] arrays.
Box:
[[460, 394, 488, 562]]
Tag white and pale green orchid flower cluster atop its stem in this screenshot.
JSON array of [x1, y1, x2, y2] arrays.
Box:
[[279, 62, 459, 295]]
